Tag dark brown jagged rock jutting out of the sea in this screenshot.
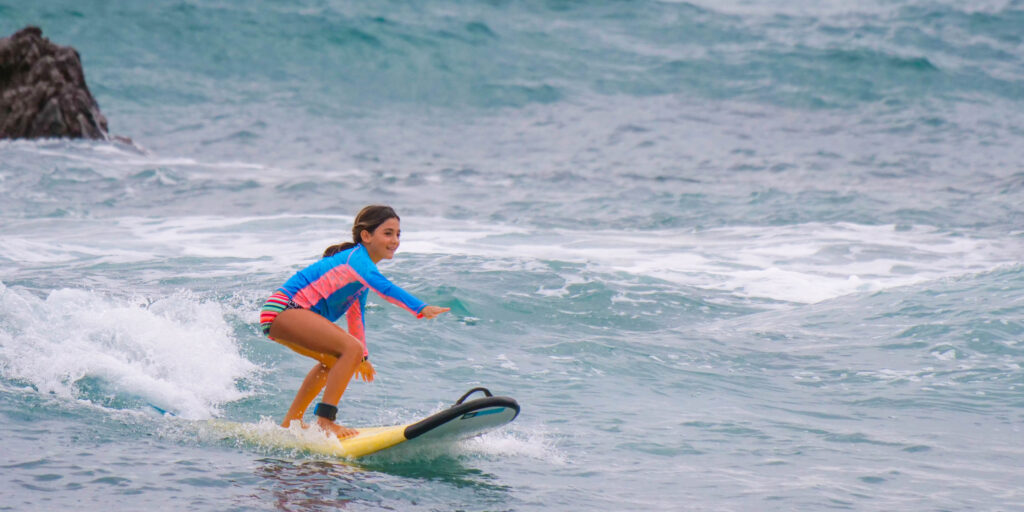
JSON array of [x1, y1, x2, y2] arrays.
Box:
[[0, 27, 109, 139]]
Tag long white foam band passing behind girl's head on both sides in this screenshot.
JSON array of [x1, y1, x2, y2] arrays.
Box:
[[6, 211, 1024, 303]]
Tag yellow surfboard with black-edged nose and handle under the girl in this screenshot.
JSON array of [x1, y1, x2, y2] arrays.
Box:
[[214, 387, 519, 459]]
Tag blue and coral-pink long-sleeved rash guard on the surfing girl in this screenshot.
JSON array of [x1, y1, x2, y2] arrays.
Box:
[[278, 244, 427, 355]]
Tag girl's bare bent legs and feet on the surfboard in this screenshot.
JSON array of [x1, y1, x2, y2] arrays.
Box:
[[270, 309, 362, 437]]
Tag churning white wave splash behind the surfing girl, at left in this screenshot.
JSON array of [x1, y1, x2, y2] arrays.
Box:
[[0, 284, 260, 418]]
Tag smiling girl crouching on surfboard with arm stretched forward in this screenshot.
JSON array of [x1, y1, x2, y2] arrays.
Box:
[[260, 206, 450, 438]]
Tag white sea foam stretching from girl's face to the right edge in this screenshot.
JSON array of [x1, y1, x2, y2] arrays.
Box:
[[403, 219, 1024, 303]]
